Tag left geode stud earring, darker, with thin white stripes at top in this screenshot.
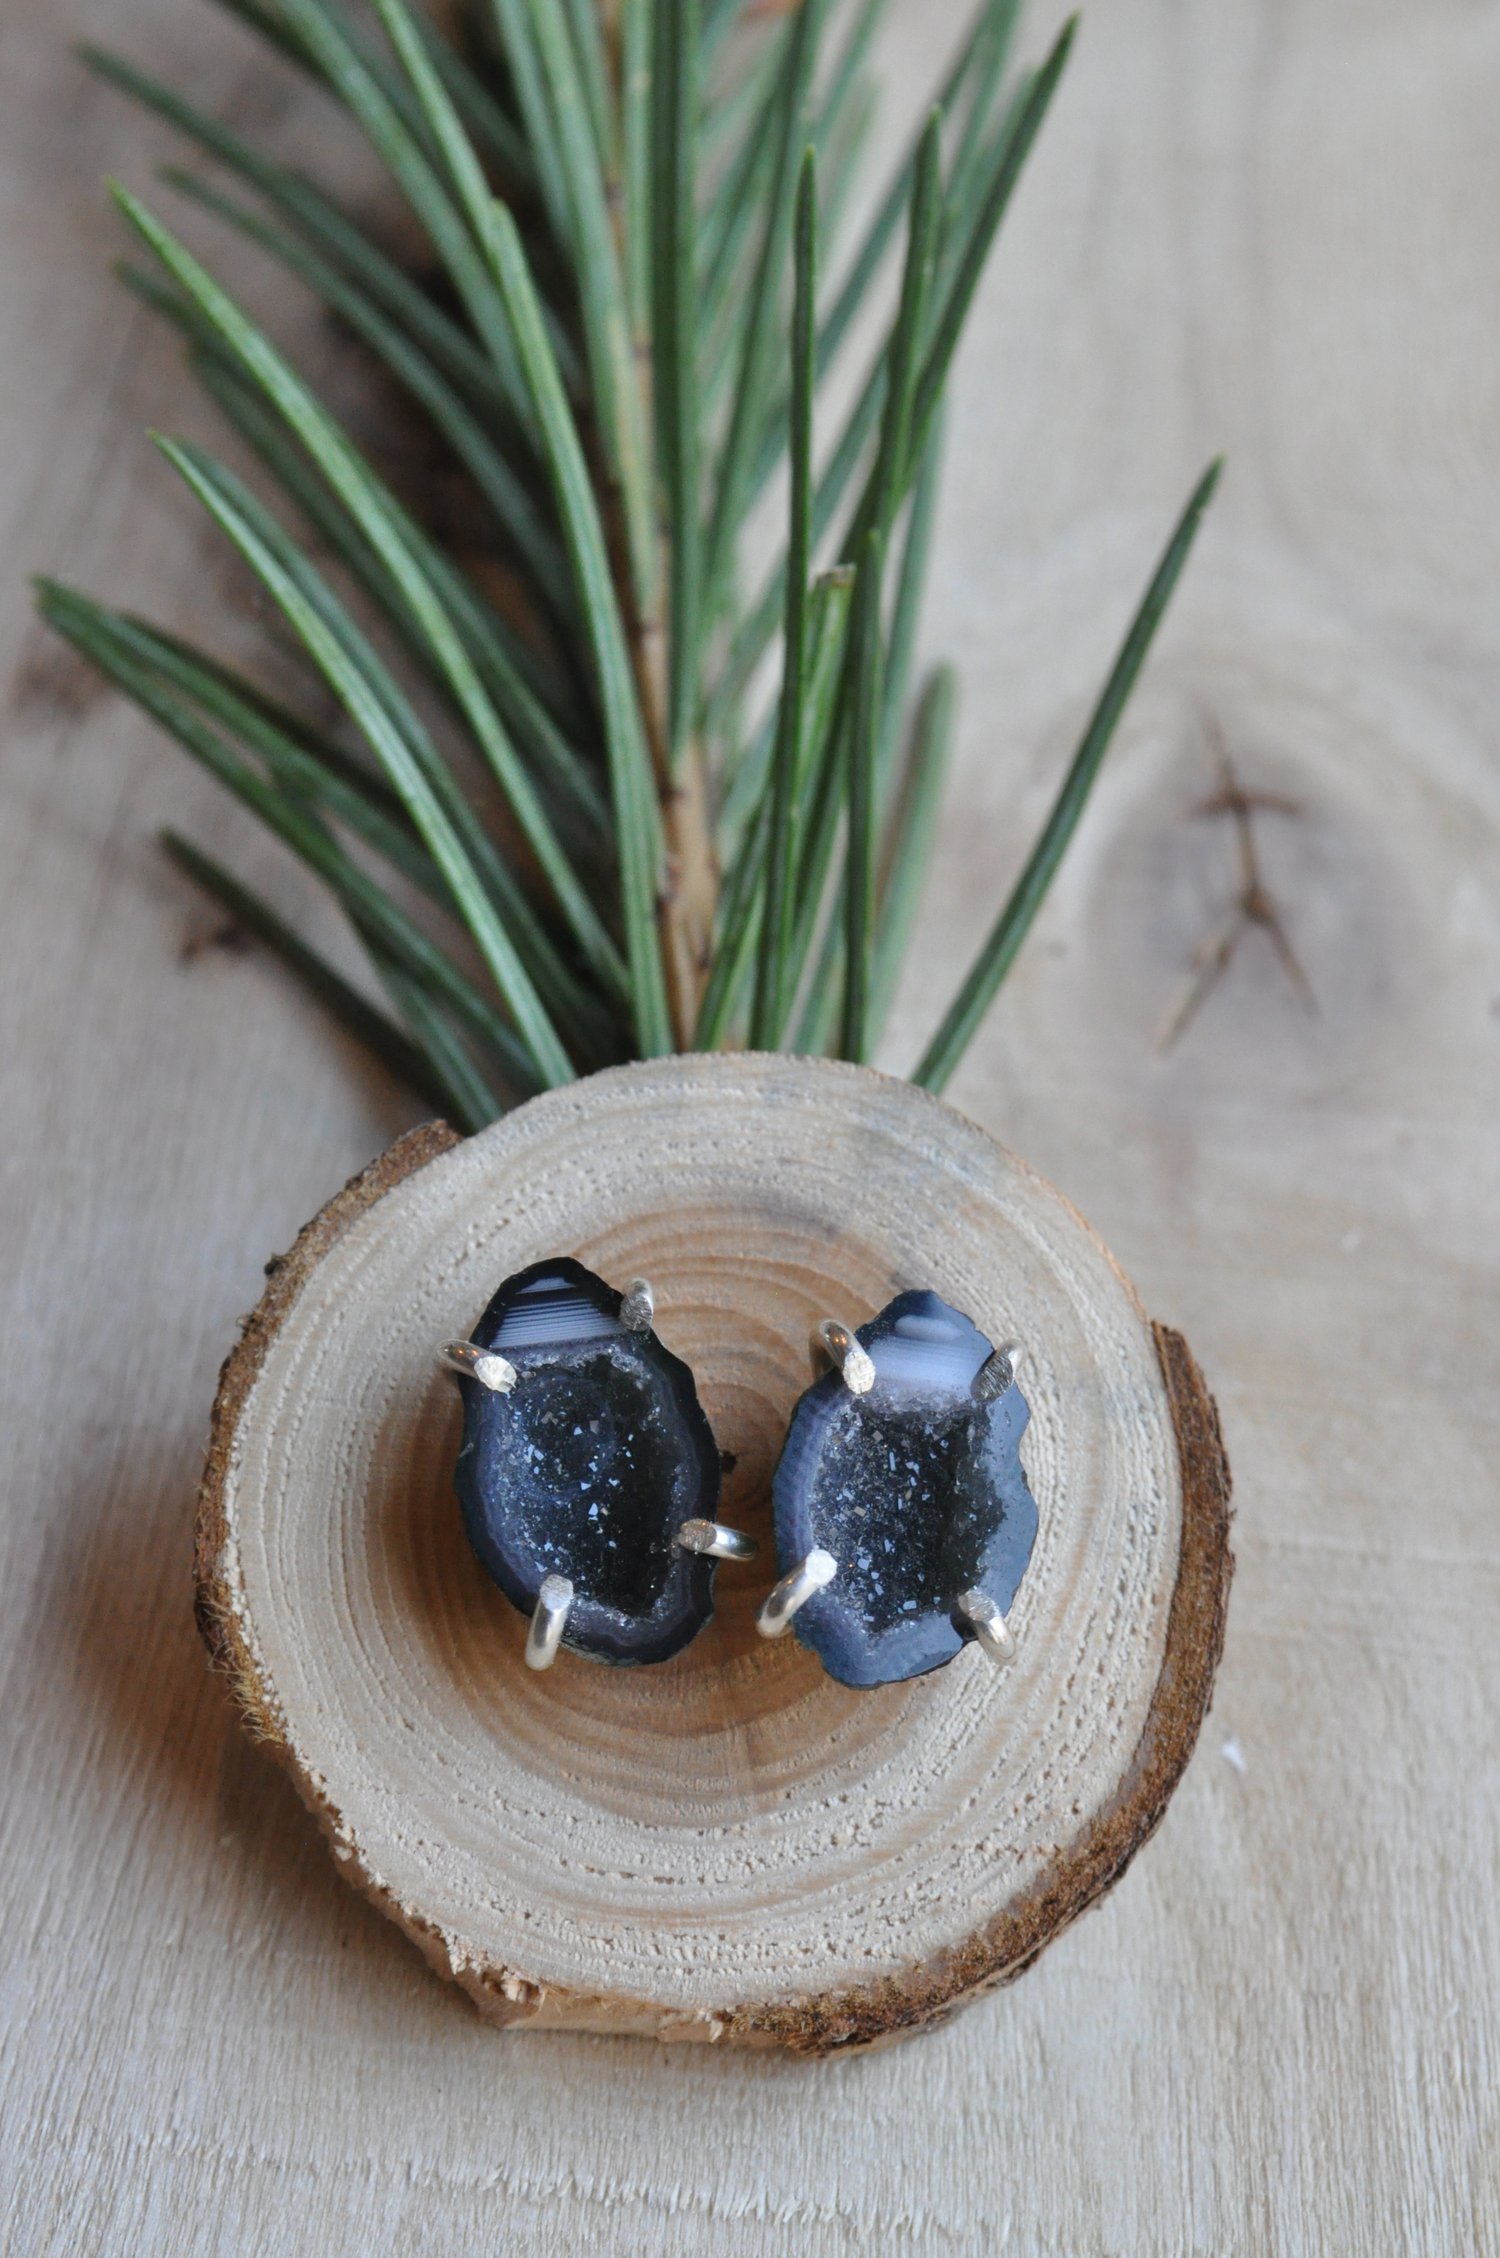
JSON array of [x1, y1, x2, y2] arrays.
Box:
[[441, 1255, 757, 1671]]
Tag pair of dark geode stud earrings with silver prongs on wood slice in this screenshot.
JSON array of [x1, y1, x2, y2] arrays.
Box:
[[441, 1258, 1037, 1687]]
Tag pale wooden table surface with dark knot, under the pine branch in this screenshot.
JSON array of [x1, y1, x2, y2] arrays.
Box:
[[0, 0, 1500, 2258]]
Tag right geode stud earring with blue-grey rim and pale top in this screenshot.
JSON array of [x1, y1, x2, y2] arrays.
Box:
[[759, 1294, 1037, 1687]]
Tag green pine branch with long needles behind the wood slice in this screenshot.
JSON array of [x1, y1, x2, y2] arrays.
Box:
[[38, 0, 1215, 1127]]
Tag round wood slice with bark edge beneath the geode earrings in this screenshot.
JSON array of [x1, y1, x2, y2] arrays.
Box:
[[197, 1054, 1231, 2053]]
